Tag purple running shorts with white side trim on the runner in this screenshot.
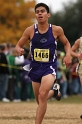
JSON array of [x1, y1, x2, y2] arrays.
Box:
[[29, 63, 57, 83]]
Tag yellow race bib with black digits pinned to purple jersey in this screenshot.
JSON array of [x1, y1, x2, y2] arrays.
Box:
[[34, 49, 49, 62]]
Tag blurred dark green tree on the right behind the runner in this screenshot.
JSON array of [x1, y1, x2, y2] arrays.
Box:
[[49, 0, 82, 50]]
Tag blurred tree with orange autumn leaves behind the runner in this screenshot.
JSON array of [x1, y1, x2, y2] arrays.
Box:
[[0, 0, 36, 47]]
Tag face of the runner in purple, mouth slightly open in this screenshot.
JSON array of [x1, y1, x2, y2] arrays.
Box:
[[35, 7, 50, 22]]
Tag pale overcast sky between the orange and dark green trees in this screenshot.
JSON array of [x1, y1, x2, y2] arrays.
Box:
[[36, 0, 77, 12]]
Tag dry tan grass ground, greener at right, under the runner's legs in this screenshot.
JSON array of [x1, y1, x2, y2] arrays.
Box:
[[0, 95, 82, 124]]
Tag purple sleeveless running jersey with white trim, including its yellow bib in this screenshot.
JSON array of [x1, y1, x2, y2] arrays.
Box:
[[30, 24, 57, 65]]
